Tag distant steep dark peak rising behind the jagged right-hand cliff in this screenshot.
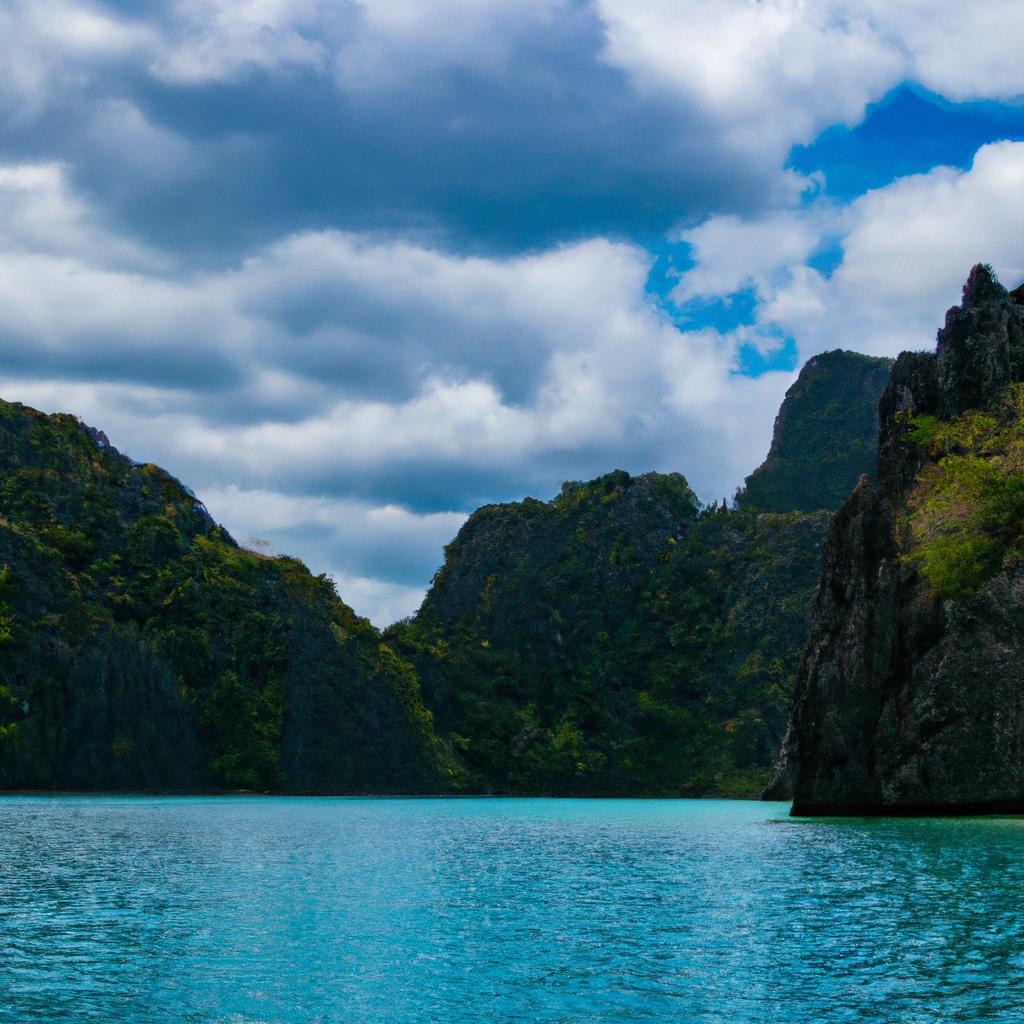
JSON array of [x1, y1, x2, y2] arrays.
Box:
[[736, 349, 892, 512]]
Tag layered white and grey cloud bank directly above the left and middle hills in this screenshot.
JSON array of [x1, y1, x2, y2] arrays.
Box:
[[0, 158, 787, 615]]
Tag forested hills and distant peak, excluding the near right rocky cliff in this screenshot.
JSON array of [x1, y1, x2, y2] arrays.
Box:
[[0, 351, 888, 796]]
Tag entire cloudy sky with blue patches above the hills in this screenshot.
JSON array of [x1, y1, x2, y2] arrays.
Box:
[[0, 0, 1024, 625]]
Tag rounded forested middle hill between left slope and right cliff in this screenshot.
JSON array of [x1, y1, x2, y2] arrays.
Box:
[[389, 471, 827, 796]]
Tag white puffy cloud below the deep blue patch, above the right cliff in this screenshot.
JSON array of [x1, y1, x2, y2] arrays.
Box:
[[679, 142, 1024, 358]]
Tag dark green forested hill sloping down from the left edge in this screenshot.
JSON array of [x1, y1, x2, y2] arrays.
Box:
[[0, 402, 457, 792]]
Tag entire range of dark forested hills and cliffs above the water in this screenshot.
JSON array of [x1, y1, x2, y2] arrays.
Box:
[[0, 266, 1024, 813]]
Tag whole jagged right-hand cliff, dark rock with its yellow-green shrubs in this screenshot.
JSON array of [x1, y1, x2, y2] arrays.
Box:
[[766, 266, 1024, 814]]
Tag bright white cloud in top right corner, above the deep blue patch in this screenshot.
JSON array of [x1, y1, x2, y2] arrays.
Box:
[[596, 0, 1024, 159]]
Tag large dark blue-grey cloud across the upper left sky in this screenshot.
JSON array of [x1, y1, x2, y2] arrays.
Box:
[[0, 0, 774, 256]]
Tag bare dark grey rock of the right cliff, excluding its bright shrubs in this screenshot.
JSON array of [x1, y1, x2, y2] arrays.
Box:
[[765, 265, 1024, 815]]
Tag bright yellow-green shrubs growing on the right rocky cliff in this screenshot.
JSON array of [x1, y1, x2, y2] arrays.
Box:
[[903, 384, 1024, 597]]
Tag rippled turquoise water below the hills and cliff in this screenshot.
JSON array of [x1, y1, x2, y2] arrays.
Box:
[[0, 797, 1024, 1024]]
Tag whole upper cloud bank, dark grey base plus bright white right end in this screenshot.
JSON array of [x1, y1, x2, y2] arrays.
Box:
[[0, 0, 1021, 265]]
